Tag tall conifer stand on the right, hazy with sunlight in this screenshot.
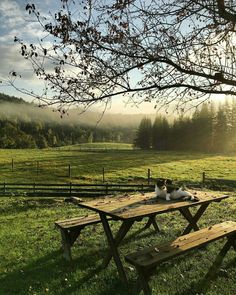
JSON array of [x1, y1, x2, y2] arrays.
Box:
[[134, 101, 236, 152]]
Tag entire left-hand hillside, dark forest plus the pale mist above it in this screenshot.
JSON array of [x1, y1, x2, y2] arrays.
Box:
[[0, 94, 139, 148]]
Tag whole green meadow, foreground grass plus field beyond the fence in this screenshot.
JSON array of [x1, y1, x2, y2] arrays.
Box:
[[0, 145, 236, 295]]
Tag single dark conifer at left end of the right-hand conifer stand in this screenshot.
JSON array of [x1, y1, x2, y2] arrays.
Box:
[[134, 118, 152, 150]]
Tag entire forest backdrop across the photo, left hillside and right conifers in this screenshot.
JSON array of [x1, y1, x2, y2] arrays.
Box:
[[0, 93, 236, 152]]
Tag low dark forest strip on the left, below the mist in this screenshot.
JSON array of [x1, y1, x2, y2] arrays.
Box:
[[0, 119, 135, 148]]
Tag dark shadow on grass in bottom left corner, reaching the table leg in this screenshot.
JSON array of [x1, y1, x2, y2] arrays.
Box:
[[0, 246, 133, 295]]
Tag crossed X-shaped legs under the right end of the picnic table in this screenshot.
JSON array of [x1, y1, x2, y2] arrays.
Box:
[[179, 203, 210, 235]]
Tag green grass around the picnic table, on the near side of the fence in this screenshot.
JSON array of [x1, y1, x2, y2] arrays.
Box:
[[0, 197, 236, 295]]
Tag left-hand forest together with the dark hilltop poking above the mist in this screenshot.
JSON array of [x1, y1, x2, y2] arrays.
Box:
[[0, 93, 136, 148]]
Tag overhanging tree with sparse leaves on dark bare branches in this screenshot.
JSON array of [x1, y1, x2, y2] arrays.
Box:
[[10, 0, 236, 109]]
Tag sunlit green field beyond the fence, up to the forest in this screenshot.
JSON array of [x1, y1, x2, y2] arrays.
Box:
[[0, 143, 236, 183]]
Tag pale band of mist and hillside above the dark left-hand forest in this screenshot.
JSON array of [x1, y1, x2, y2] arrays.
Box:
[[0, 93, 155, 128]]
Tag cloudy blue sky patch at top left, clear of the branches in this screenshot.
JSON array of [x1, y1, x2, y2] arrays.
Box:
[[0, 0, 55, 93]]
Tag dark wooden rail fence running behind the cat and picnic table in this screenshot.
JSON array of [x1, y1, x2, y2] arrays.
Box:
[[0, 172, 236, 197]]
